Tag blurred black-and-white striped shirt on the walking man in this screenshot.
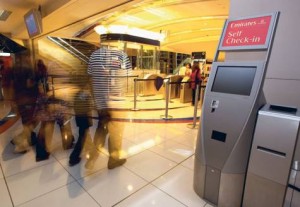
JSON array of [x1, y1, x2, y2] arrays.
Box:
[[88, 48, 132, 109]]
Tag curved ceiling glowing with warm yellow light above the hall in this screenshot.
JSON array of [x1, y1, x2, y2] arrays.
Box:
[[0, 0, 229, 56]]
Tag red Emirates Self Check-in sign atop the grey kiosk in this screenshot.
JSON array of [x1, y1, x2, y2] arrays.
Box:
[[221, 15, 273, 49]]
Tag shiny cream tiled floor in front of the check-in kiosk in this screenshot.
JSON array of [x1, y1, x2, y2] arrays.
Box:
[[0, 97, 211, 207]]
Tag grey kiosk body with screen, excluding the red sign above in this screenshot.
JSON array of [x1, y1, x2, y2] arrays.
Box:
[[194, 62, 264, 207]]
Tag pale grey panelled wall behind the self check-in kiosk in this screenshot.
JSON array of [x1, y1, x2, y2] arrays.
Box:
[[226, 0, 300, 107]]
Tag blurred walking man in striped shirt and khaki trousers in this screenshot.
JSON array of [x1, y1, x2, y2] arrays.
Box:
[[85, 47, 132, 169]]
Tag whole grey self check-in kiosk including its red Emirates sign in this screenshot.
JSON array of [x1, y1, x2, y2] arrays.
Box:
[[194, 12, 279, 207]]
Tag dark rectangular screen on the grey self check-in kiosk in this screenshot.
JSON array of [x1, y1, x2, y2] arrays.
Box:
[[211, 66, 256, 96]]
